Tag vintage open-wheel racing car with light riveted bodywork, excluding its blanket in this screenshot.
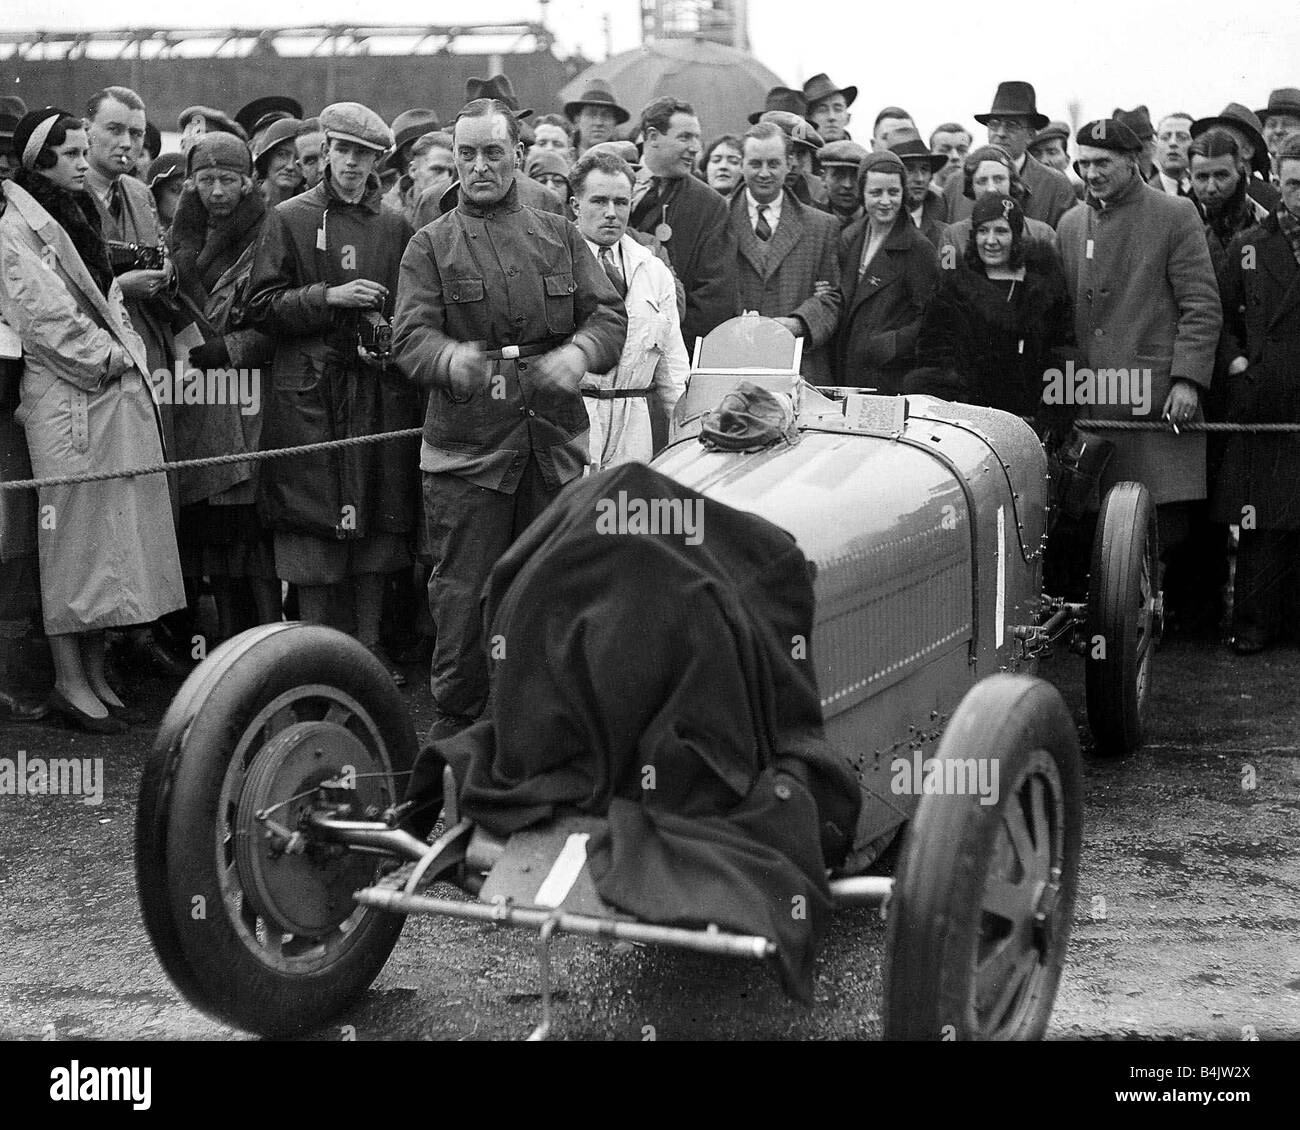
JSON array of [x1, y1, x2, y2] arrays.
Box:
[[137, 317, 1160, 1039]]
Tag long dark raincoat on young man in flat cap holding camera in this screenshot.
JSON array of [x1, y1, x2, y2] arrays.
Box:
[[246, 173, 420, 540]]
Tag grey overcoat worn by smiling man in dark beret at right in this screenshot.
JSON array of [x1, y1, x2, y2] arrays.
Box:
[[1057, 177, 1223, 503]]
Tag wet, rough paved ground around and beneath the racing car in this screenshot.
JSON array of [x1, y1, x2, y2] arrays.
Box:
[[0, 629, 1300, 1039]]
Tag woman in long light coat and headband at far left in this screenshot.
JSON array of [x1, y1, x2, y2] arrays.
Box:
[[0, 108, 185, 733]]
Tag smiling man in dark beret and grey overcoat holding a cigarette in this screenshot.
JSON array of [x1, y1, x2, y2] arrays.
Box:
[[1058, 120, 1223, 585]]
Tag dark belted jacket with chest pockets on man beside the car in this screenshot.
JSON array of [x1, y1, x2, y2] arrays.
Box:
[[393, 185, 628, 494]]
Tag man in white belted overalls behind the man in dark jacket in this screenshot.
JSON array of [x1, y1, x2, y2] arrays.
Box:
[[569, 152, 690, 471]]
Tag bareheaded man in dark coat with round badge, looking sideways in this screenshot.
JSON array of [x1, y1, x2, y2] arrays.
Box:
[[628, 98, 737, 356]]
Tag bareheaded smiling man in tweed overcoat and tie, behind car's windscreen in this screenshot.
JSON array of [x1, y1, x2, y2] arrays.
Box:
[[729, 122, 840, 385]]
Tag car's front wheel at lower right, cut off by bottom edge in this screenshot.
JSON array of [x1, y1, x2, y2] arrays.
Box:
[[884, 675, 1083, 1040]]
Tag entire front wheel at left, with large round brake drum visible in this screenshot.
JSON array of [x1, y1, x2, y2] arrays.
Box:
[[135, 624, 416, 1036]]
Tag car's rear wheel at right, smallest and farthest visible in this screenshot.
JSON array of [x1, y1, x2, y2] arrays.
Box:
[[1086, 482, 1161, 757]]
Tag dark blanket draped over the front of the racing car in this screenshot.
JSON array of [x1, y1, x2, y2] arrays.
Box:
[[412, 464, 859, 1000]]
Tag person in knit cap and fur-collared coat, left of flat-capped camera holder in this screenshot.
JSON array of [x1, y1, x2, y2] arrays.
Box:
[[170, 133, 280, 640]]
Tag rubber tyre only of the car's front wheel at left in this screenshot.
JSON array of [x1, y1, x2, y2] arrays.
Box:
[[135, 623, 417, 1036]]
